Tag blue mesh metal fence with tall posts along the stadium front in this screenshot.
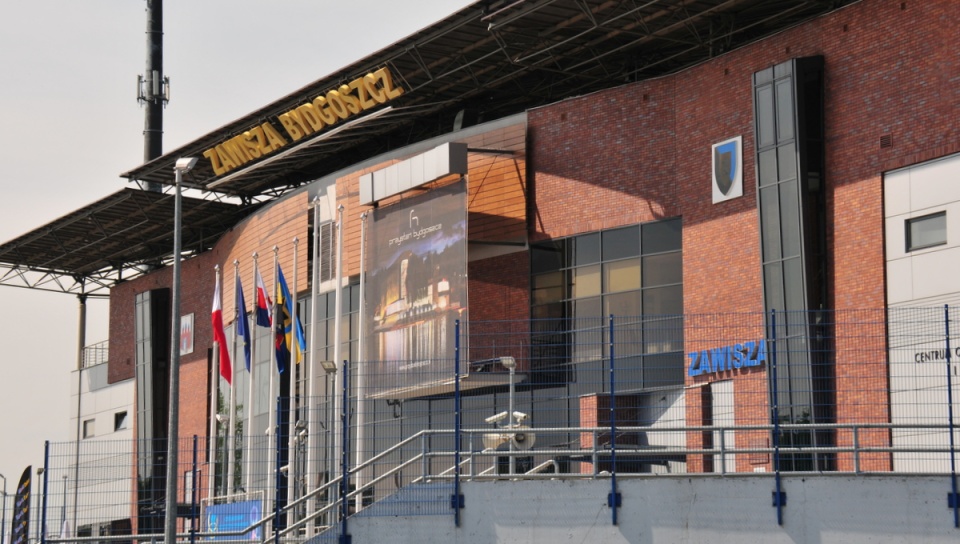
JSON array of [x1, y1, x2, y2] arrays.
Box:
[[30, 307, 960, 542]]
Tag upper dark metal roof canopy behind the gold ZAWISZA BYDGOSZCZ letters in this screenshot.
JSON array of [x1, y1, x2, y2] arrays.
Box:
[[122, 0, 854, 198]]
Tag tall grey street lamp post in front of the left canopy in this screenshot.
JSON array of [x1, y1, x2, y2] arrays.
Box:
[[163, 157, 197, 544]]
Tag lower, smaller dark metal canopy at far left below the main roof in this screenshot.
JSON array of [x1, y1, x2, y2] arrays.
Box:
[[0, 189, 250, 294]]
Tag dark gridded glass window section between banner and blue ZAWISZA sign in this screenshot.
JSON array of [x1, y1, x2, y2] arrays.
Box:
[[530, 218, 684, 389]]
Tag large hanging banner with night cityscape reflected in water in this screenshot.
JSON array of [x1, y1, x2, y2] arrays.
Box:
[[364, 180, 467, 398]]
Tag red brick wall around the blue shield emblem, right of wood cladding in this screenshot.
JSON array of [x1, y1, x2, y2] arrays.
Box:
[[529, 0, 960, 468]]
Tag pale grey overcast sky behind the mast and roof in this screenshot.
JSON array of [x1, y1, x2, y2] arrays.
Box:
[[0, 0, 472, 502]]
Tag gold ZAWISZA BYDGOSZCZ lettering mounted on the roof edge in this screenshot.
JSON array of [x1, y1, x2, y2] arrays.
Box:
[[203, 68, 403, 176]]
